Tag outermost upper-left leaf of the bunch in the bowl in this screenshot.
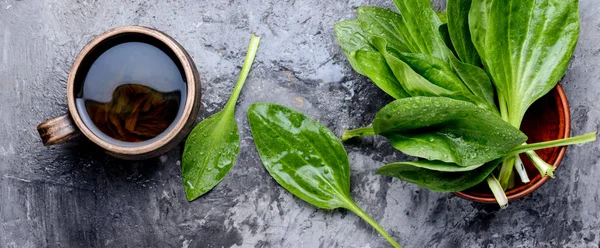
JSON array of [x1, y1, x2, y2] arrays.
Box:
[[334, 20, 409, 99]]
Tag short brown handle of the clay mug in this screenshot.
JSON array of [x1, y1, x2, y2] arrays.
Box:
[[37, 114, 80, 146]]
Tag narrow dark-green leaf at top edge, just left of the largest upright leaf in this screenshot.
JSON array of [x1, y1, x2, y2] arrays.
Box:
[[446, 0, 481, 66]]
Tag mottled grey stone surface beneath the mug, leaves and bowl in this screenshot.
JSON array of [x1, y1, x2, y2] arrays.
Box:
[[0, 0, 600, 248]]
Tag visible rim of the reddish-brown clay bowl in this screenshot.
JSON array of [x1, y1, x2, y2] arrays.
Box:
[[454, 84, 571, 203]]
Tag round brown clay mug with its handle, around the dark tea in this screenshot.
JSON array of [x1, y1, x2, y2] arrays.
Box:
[[37, 26, 201, 160]]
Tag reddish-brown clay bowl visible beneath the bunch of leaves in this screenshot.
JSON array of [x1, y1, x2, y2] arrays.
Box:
[[455, 85, 571, 203]]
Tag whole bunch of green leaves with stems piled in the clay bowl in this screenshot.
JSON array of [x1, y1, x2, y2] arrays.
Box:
[[335, 0, 596, 206]]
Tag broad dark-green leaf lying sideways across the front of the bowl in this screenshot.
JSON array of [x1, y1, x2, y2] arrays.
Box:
[[373, 97, 527, 166]]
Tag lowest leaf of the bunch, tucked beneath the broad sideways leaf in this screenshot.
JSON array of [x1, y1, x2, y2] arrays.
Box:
[[377, 159, 500, 192]]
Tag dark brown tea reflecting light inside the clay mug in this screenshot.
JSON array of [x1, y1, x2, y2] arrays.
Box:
[[75, 41, 187, 142]]
